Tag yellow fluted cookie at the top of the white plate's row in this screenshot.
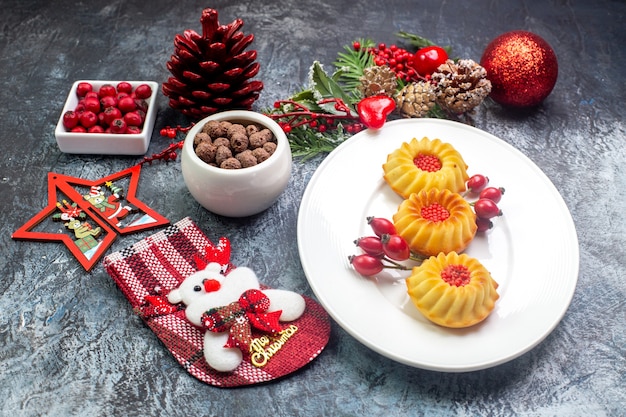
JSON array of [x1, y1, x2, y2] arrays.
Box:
[[383, 137, 469, 198]]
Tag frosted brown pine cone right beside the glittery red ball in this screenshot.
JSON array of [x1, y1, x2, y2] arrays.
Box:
[[432, 59, 491, 114]]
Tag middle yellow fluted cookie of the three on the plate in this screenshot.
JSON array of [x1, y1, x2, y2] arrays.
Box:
[[393, 188, 478, 256]]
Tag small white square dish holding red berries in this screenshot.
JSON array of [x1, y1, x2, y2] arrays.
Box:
[[54, 80, 159, 155]]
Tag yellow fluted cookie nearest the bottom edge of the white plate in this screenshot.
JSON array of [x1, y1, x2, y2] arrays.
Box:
[[406, 252, 499, 328]]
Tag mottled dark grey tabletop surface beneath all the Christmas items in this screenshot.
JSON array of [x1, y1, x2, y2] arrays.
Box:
[[0, 0, 626, 416]]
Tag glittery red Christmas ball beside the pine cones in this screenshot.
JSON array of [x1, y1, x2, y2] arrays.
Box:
[[480, 30, 559, 107]]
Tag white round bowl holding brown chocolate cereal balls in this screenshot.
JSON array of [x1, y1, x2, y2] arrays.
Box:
[[181, 110, 292, 217]]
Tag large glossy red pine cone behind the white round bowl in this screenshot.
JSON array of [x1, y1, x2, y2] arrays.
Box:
[[162, 9, 263, 119]]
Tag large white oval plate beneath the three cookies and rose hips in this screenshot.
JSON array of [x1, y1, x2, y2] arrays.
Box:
[[298, 119, 579, 372]]
